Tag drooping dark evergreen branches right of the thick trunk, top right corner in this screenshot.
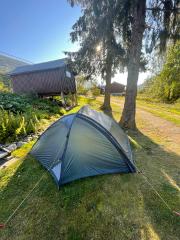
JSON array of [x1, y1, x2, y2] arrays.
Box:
[[145, 0, 180, 53]]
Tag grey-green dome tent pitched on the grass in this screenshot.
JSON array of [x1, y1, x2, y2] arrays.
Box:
[[30, 106, 136, 186]]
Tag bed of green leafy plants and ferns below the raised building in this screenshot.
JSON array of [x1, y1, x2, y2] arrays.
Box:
[[0, 93, 63, 143]]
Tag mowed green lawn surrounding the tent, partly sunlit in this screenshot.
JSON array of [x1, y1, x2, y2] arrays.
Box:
[[0, 98, 180, 240]]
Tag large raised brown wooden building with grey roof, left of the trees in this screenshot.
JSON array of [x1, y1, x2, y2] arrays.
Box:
[[10, 58, 76, 96]]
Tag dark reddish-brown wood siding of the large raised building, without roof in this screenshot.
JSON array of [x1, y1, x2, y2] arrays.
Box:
[[11, 68, 76, 95]]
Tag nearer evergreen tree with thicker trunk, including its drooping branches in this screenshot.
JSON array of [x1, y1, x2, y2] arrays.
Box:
[[119, 0, 180, 129]]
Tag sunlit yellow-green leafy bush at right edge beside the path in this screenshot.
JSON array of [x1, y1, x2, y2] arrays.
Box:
[[142, 41, 180, 102]]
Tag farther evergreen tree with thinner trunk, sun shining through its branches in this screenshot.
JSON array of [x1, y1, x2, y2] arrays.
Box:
[[69, 0, 126, 112]]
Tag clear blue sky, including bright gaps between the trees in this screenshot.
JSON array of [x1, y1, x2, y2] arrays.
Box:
[[0, 0, 147, 84]]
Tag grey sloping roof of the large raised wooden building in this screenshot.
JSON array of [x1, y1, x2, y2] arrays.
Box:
[[9, 58, 67, 75]]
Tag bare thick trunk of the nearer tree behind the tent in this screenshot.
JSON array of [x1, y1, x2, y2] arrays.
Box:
[[120, 0, 146, 129]]
